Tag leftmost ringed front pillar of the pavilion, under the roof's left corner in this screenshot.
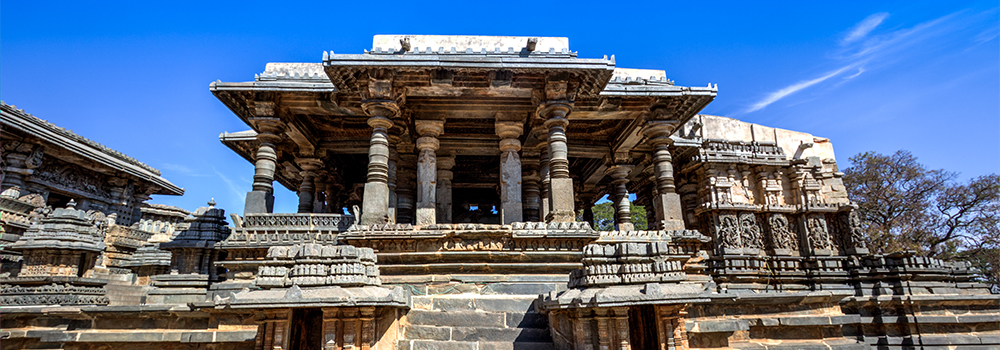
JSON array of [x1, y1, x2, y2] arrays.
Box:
[[243, 119, 281, 215]]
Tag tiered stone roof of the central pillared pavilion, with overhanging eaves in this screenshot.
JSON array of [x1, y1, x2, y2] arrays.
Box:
[[210, 35, 718, 200]]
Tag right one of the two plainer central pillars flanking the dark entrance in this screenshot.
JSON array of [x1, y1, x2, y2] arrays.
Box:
[[496, 121, 524, 225]]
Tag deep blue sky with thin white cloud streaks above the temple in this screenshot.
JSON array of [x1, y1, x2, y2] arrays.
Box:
[[0, 0, 1000, 213]]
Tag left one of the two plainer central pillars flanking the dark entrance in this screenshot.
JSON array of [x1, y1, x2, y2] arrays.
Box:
[[416, 120, 444, 225]]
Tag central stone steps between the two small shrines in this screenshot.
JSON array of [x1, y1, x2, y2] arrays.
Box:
[[397, 289, 553, 350]]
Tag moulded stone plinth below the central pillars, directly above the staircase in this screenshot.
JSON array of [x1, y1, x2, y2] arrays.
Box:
[[340, 222, 598, 276]]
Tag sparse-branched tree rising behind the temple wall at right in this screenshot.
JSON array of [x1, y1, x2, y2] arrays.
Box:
[[844, 150, 1000, 285]]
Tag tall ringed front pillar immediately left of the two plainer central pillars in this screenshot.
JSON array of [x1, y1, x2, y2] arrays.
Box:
[[360, 101, 399, 225]]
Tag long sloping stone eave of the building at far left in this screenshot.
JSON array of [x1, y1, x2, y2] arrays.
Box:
[[0, 103, 184, 195]]
